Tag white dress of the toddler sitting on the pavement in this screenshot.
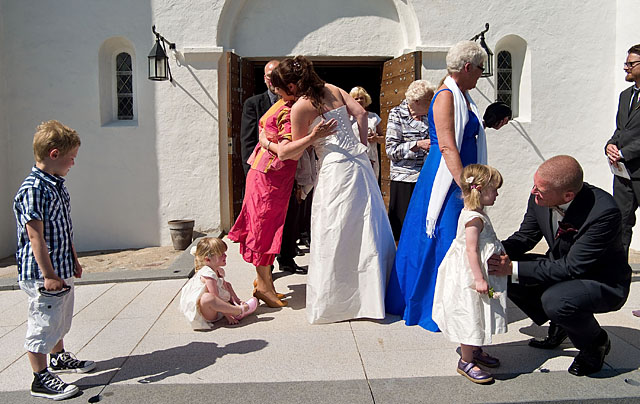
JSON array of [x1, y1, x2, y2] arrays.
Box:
[[180, 265, 231, 330]]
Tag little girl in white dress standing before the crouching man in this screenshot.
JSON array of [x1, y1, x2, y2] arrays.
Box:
[[432, 164, 507, 383]]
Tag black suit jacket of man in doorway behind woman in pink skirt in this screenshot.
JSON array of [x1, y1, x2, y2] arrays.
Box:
[[240, 91, 271, 175]]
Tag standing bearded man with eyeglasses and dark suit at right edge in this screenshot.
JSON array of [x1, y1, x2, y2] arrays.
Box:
[[605, 44, 640, 254]]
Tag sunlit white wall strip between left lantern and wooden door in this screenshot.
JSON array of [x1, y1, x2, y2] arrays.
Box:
[[147, 0, 230, 240]]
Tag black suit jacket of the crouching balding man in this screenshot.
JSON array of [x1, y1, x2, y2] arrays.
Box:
[[502, 183, 631, 297]]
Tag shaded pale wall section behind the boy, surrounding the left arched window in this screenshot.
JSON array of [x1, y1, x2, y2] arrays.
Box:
[[5, 1, 159, 250]]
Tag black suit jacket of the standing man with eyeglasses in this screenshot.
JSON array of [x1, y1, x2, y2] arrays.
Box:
[[607, 86, 640, 179]]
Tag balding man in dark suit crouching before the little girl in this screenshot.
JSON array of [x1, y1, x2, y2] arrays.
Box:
[[489, 156, 631, 376]]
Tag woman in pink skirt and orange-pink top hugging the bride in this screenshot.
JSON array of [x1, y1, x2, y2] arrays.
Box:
[[228, 76, 335, 307]]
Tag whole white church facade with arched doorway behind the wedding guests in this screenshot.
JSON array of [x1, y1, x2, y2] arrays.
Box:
[[0, 0, 640, 256]]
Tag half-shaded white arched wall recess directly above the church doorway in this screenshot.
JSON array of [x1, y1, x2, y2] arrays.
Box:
[[228, 0, 407, 57]]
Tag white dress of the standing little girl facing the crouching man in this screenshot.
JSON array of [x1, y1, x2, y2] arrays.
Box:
[[432, 209, 507, 346]]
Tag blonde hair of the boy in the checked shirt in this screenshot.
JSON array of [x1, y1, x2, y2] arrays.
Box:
[[33, 120, 80, 163]]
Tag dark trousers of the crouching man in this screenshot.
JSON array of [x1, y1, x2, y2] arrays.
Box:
[[507, 272, 629, 350]]
